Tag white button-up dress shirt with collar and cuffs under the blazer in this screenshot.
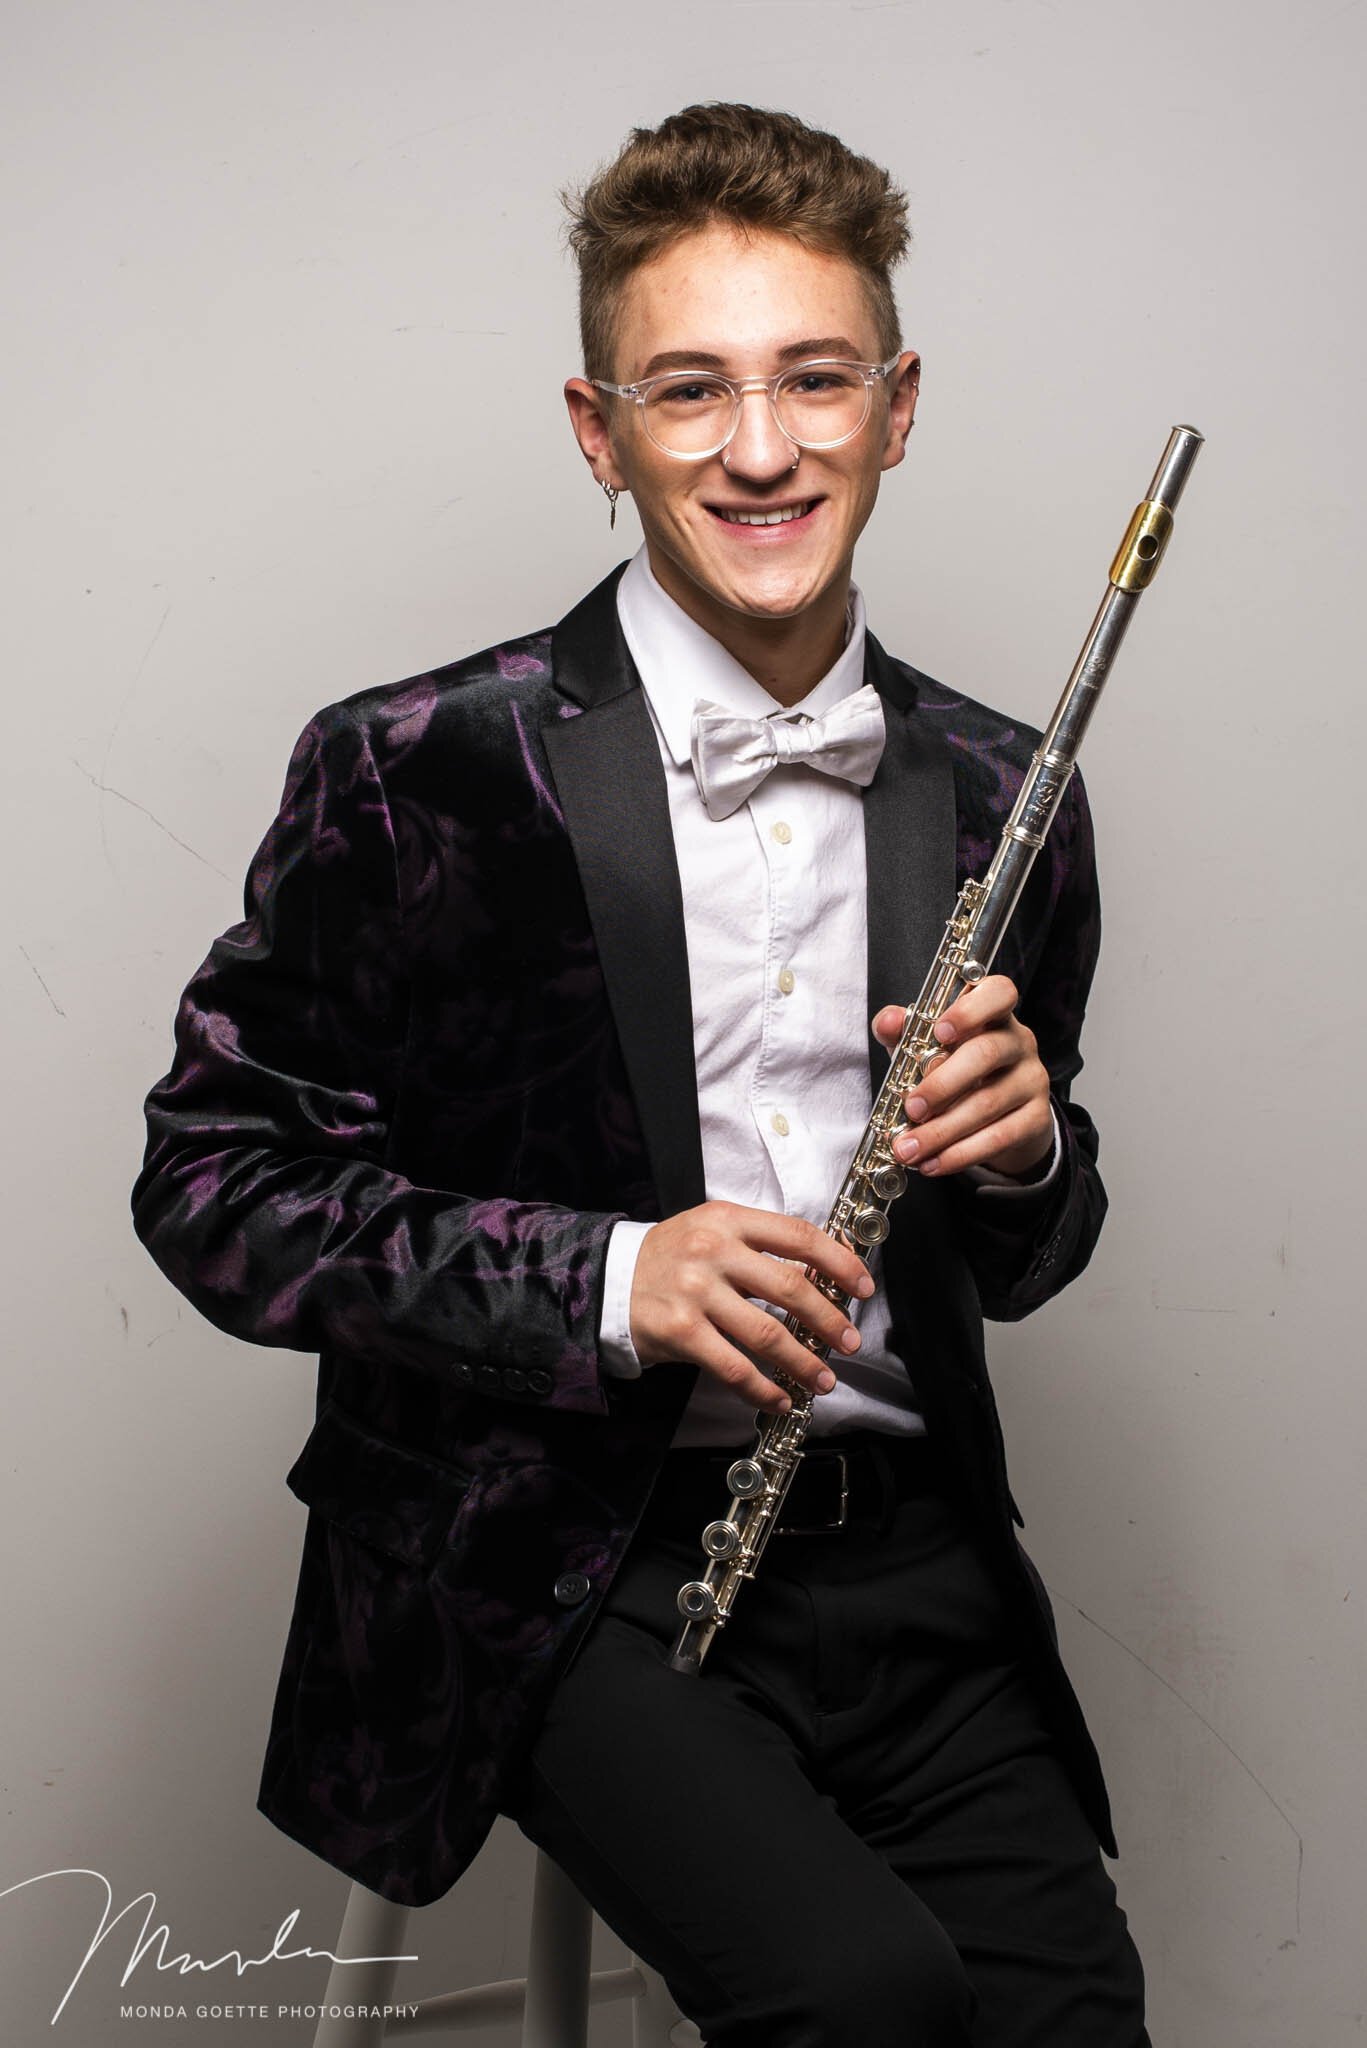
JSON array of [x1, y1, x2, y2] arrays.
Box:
[[598, 547, 1060, 1448]]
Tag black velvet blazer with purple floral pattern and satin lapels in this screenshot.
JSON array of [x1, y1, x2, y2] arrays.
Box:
[[133, 569, 1115, 1905]]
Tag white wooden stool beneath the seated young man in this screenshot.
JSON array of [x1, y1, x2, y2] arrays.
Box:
[[314, 1849, 703, 2048]]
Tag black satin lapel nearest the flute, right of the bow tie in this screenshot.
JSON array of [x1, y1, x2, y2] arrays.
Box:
[[863, 635, 957, 1090]]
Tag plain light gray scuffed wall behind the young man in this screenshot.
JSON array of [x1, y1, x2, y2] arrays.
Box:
[[0, 0, 1367, 2048]]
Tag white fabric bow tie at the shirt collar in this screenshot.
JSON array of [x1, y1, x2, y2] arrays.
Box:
[[693, 682, 885, 817]]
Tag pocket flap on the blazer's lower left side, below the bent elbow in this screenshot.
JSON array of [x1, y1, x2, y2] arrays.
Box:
[[285, 1401, 473, 1575]]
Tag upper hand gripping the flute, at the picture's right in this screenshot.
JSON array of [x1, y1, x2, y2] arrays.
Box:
[[873, 975, 1053, 1176]]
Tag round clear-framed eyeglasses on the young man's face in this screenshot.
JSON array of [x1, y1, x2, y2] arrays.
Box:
[[590, 354, 902, 463]]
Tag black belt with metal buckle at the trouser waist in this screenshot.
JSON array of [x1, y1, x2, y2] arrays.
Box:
[[646, 1430, 937, 1538]]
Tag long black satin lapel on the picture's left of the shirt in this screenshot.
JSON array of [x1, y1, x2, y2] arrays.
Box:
[[543, 653, 705, 1217]]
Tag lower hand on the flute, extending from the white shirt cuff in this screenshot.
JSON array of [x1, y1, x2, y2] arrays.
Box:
[[631, 1202, 873, 1415]]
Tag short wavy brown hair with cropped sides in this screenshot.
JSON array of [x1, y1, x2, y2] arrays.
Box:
[[562, 100, 910, 377]]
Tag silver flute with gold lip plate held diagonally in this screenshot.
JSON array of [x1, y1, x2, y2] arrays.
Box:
[[668, 426, 1203, 1671]]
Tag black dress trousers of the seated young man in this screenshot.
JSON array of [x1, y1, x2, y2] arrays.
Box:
[[502, 1434, 1148, 2048]]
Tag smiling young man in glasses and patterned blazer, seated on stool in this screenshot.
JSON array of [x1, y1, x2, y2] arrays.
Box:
[[135, 106, 1146, 2048]]
